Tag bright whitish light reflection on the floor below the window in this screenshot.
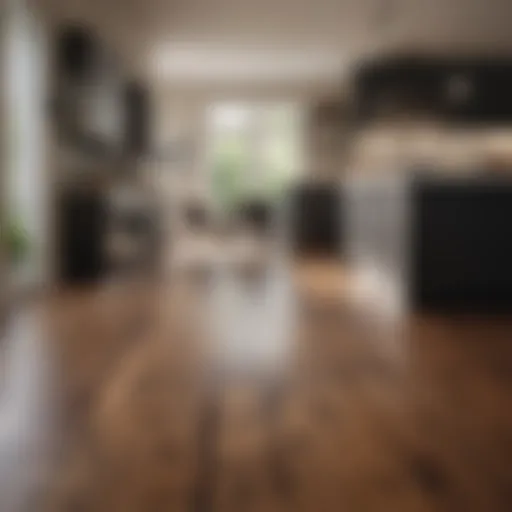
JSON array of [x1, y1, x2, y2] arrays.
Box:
[[207, 268, 296, 374]]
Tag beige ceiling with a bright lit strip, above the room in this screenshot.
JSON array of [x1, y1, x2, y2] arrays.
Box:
[[37, 0, 512, 83]]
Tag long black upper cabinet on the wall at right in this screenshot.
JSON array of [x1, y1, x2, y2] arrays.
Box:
[[355, 57, 512, 124]]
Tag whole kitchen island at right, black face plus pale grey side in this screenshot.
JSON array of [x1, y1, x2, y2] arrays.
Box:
[[345, 176, 512, 314]]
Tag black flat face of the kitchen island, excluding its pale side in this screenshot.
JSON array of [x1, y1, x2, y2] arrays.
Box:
[[410, 179, 512, 312]]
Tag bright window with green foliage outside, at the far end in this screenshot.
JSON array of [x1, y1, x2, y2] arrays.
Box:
[[210, 103, 302, 210]]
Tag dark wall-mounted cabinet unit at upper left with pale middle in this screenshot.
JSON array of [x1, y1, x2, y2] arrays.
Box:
[[54, 24, 150, 158]]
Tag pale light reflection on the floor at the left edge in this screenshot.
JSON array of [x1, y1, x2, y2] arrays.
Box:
[[0, 311, 57, 512]]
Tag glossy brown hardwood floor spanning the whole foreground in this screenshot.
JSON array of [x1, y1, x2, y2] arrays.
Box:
[[0, 263, 512, 512]]
